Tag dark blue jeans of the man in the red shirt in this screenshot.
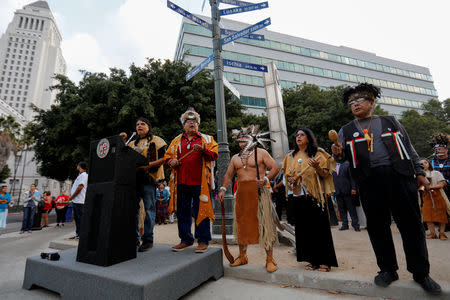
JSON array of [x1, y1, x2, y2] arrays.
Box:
[[177, 184, 211, 245]]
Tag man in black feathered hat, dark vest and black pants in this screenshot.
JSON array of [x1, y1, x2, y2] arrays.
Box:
[[332, 83, 441, 294]]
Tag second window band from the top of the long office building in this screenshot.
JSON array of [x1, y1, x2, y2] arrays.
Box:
[[183, 44, 437, 96]]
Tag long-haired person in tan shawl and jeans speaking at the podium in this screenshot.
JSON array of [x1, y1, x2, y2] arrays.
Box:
[[121, 117, 167, 252]]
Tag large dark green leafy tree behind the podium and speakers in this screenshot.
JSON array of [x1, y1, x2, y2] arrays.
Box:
[[32, 59, 267, 181]]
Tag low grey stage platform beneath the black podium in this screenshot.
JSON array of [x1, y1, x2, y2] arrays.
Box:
[[23, 244, 224, 300]]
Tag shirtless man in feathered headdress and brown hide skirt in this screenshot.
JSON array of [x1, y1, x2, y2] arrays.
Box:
[[218, 125, 279, 273]]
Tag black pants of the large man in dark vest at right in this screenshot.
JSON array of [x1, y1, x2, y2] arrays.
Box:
[[358, 166, 430, 276]]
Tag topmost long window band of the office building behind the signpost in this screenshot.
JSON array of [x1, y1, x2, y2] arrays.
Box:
[[183, 23, 433, 82]]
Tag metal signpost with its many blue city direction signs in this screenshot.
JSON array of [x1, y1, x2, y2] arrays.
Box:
[[167, 0, 270, 235]]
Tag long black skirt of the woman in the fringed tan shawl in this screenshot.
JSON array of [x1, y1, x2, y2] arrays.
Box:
[[295, 195, 338, 267]]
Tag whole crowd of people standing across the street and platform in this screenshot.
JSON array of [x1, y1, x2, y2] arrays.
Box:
[[0, 83, 450, 294]]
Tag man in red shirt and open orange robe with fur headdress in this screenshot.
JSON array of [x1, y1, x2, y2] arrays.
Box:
[[164, 108, 219, 253]]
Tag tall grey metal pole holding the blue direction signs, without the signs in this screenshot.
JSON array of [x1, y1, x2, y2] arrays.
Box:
[[209, 0, 234, 235]]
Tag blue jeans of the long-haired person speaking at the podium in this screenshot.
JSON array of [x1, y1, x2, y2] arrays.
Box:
[[136, 183, 156, 243]]
